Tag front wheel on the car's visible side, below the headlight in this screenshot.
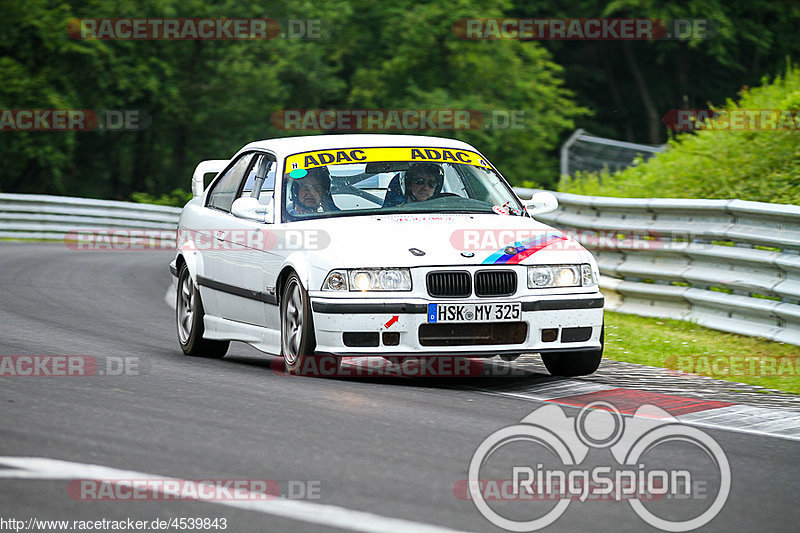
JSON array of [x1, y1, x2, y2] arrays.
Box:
[[281, 272, 332, 376]]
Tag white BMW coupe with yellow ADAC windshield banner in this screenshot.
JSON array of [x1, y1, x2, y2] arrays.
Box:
[[170, 135, 603, 376]]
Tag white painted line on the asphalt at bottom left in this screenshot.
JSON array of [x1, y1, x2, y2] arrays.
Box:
[[0, 456, 476, 533]]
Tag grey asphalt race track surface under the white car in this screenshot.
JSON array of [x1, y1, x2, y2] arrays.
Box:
[[0, 243, 800, 532]]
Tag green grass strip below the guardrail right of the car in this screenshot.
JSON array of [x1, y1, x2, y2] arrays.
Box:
[[604, 311, 800, 394]]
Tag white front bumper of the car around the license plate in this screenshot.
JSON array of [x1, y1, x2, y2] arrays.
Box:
[[310, 292, 604, 357]]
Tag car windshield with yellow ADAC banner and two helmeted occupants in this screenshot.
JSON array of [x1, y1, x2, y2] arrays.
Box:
[[283, 147, 523, 220]]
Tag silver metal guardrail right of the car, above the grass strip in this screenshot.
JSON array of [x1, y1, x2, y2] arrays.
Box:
[[515, 188, 800, 345]]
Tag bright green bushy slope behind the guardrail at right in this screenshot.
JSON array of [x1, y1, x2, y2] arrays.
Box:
[[559, 66, 800, 204]]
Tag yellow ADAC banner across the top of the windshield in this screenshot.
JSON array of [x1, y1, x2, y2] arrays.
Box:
[[286, 147, 491, 173]]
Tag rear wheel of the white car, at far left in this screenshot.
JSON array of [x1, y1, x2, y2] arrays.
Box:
[[175, 264, 231, 359]]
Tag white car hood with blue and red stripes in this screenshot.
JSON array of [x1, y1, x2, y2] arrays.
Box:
[[291, 214, 591, 268]]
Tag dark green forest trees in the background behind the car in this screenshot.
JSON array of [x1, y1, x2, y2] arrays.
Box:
[[0, 0, 800, 199]]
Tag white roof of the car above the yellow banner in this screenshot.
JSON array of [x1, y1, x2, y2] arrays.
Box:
[[237, 134, 475, 155]]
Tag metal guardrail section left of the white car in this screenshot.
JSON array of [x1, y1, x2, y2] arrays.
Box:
[[0, 193, 181, 244]]
